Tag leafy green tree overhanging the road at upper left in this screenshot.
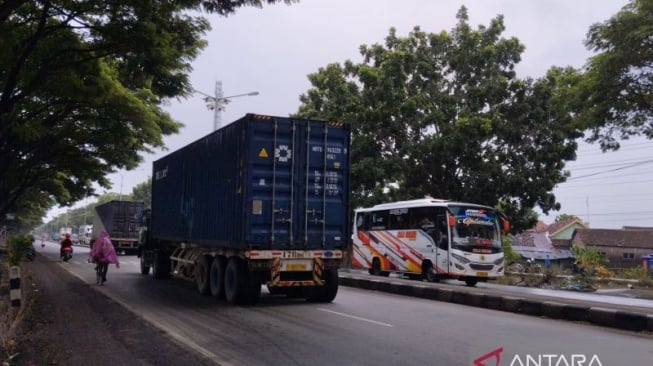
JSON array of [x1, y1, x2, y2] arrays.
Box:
[[0, 0, 293, 217]]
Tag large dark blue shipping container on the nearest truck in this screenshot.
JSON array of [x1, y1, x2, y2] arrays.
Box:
[[151, 114, 350, 250]]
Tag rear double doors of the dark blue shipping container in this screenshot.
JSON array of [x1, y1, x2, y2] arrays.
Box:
[[247, 117, 349, 250]]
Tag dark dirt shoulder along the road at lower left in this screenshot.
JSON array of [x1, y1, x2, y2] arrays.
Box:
[[0, 255, 213, 366]]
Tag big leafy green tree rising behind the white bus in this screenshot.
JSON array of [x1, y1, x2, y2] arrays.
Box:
[[297, 7, 580, 230]]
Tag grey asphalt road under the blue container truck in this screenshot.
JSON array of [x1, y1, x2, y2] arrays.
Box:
[[37, 243, 653, 365]]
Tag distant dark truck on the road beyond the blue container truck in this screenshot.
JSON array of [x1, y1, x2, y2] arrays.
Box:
[[91, 200, 145, 254]]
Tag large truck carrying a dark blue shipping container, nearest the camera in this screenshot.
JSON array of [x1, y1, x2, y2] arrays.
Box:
[[139, 114, 350, 304]]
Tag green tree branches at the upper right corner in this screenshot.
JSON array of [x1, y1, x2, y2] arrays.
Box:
[[577, 0, 653, 150]]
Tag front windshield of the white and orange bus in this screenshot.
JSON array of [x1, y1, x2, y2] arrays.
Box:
[[449, 206, 502, 254]]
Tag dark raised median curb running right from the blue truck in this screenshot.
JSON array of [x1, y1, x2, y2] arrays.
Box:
[[339, 272, 653, 332]]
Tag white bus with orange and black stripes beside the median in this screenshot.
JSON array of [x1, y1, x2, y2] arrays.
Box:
[[352, 198, 510, 286]]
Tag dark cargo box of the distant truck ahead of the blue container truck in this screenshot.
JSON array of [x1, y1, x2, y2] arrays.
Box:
[[95, 200, 144, 239]]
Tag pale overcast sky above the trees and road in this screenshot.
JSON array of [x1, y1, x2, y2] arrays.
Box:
[[47, 0, 653, 228]]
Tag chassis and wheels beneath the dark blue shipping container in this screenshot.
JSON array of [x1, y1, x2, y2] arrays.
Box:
[[139, 245, 343, 305]]
